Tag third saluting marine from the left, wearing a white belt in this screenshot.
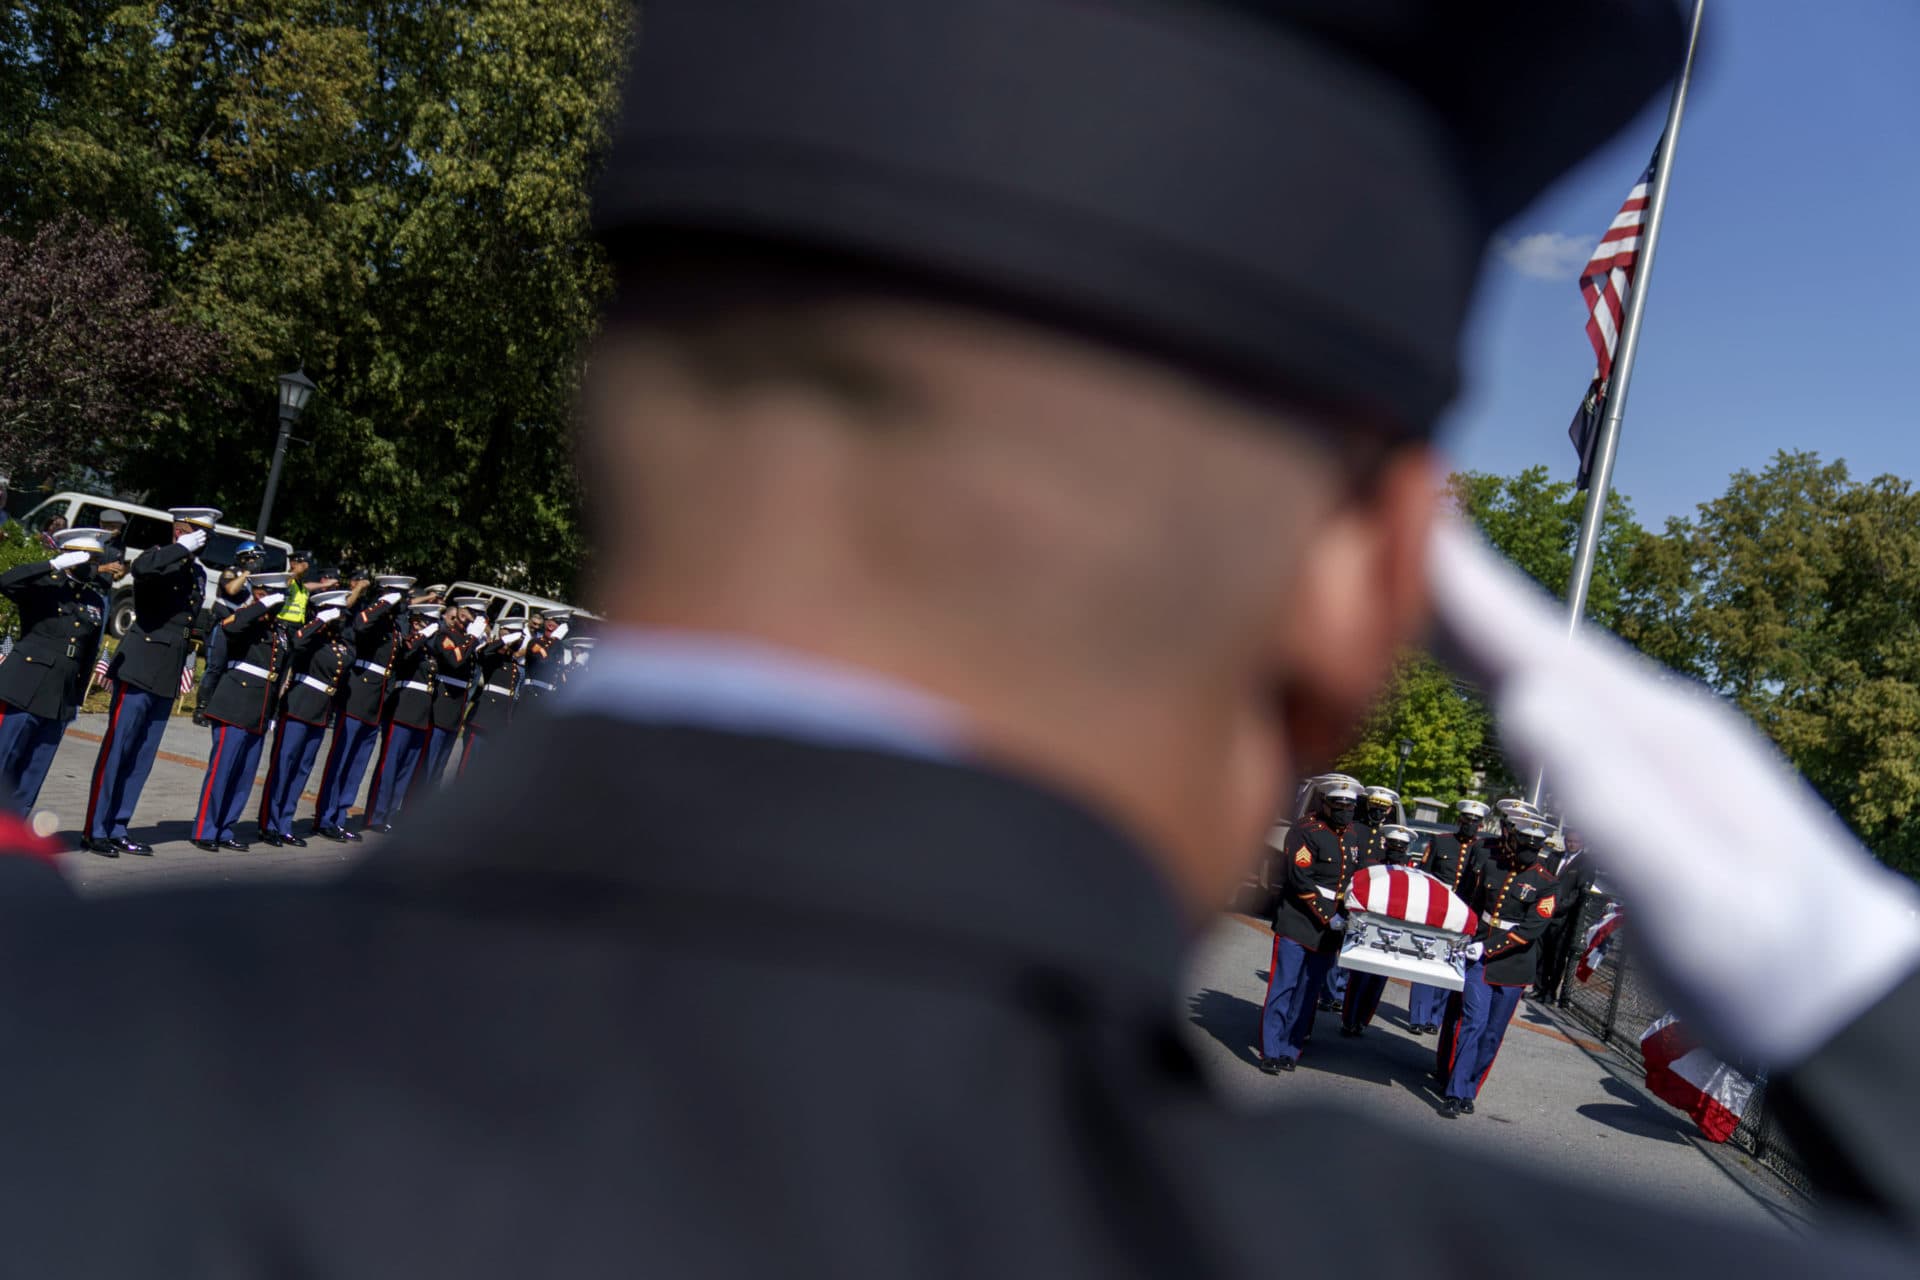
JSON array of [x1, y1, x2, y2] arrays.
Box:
[[192, 574, 286, 854]]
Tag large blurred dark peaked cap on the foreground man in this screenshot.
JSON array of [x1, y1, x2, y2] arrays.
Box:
[[595, 0, 1682, 436]]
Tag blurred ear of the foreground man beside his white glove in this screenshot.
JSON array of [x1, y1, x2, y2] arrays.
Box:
[[1277, 449, 1440, 775]]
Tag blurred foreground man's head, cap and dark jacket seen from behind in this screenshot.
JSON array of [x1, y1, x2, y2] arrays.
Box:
[[0, 0, 1920, 1280]]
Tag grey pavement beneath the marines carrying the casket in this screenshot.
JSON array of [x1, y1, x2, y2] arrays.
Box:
[[1188, 915, 1811, 1230]]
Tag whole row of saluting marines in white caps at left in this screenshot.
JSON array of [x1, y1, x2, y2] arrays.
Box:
[[0, 507, 589, 858]]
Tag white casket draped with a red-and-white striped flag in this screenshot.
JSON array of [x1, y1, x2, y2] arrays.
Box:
[[1340, 865, 1480, 990]]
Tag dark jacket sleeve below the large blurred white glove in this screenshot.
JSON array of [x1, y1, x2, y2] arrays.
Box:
[[1764, 973, 1920, 1240]]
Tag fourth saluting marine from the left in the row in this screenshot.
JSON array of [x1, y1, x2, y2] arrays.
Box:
[[259, 591, 353, 848]]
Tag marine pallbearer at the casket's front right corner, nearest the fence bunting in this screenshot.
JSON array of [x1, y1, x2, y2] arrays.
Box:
[[1440, 812, 1555, 1117]]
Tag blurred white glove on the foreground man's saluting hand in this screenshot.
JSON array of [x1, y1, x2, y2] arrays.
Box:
[[1430, 524, 1920, 1069]]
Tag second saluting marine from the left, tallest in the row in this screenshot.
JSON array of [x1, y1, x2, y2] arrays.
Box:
[[81, 507, 221, 858]]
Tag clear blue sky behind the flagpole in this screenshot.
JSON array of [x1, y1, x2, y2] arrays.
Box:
[[1442, 0, 1920, 526]]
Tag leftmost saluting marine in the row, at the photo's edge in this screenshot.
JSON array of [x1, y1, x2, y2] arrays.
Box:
[[0, 530, 108, 816]]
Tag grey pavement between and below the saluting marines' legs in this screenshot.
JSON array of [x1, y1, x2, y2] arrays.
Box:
[[35, 714, 380, 892]]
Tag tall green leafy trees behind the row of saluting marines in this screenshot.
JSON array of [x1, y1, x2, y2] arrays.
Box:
[[0, 0, 630, 593]]
